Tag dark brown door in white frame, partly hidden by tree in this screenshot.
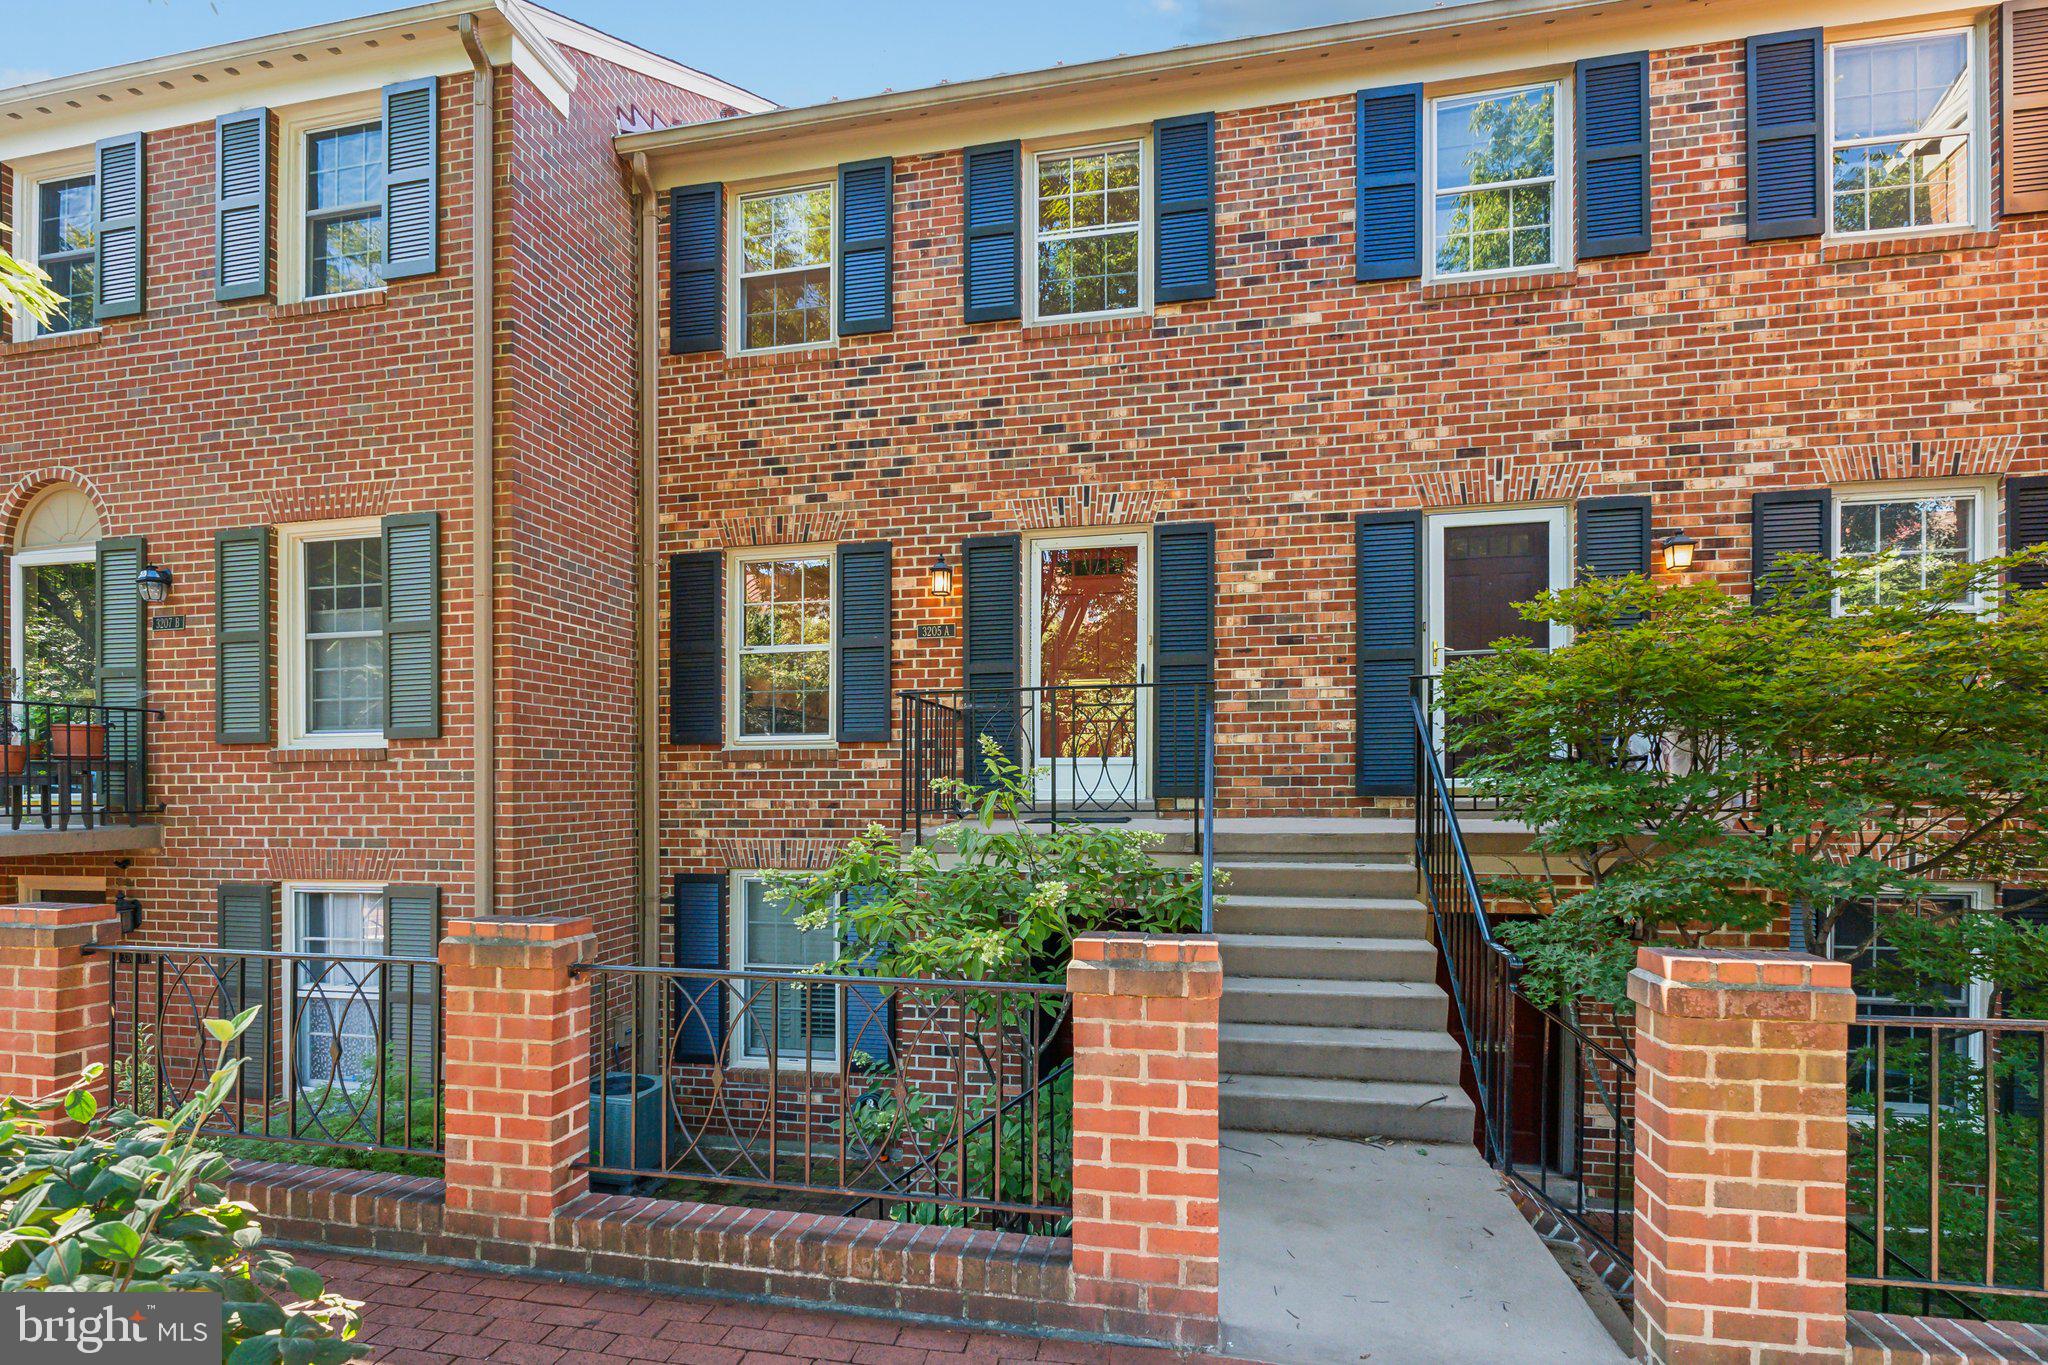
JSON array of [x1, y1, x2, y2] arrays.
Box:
[[1423, 508, 1571, 769]]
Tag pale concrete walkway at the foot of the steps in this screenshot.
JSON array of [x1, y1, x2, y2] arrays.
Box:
[[1223, 1132, 1628, 1365]]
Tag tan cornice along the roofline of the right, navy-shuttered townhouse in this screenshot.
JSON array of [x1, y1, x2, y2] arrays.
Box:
[[618, 0, 1989, 188]]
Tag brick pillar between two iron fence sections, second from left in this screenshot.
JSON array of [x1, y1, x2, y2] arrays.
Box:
[[440, 917, 594, 1242]]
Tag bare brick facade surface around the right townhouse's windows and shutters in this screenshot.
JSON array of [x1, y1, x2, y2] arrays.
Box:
[[659, 31, 2048, 900]]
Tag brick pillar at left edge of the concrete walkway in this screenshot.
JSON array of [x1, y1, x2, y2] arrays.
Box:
[[1067, 933, 1223, 1347]]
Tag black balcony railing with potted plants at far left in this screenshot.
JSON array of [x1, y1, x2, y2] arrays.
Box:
[[0, 698, 162, 829]]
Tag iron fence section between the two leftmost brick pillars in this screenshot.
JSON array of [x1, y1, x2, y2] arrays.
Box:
[[96, 943, 442, 1154]]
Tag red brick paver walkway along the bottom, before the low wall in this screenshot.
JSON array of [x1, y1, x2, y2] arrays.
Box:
[[299, 1252, 1212, 1365]]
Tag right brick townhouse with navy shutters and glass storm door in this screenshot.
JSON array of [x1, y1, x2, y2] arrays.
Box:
[[634, 0, 2048, 994]]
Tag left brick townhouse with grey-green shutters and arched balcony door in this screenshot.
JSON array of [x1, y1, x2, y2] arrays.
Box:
[[0, 0, 766, 1002]]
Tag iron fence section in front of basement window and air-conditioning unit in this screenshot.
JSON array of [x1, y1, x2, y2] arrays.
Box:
[[578, 966, 1073, 1232]]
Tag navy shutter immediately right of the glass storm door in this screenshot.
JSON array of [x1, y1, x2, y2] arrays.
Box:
[[1153, 522, 1217, 796]]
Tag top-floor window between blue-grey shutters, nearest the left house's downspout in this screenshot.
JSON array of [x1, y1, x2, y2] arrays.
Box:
[[276, 90, 385, 303]]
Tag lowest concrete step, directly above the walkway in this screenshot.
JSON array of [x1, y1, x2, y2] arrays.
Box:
[[1223, 1076, 1473, 1142]]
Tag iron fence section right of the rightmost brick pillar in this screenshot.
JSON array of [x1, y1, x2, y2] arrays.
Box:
[[1847, 1015, 2048, 1322]]
